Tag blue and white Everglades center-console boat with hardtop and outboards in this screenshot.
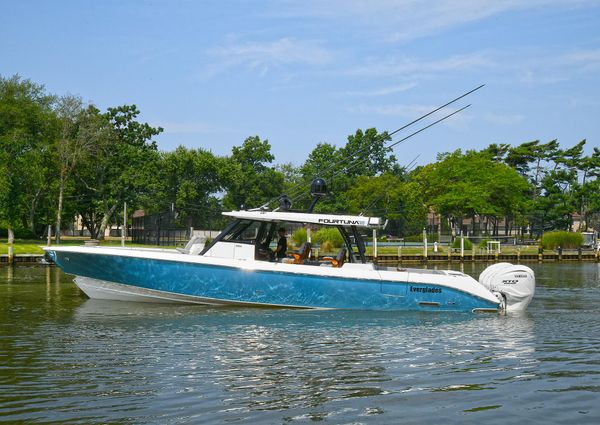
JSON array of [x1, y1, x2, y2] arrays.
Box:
[[44, 209, 535, 312]]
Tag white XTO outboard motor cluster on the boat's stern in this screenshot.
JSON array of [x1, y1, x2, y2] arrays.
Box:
[[479, 263, 535, 313]]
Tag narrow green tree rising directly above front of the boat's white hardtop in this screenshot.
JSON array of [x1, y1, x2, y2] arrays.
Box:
[[223, 136, 283, 209]]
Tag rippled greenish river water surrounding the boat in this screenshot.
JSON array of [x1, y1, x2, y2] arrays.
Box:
[[0, 263, 600, 424]]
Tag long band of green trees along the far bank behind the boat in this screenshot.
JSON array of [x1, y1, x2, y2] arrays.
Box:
[[0, 75, 600, 243]]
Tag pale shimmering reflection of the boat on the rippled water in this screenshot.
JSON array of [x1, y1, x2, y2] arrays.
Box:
[[69, 300, 536, 419]]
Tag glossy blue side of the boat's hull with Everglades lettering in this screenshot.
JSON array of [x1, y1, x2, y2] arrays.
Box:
[[52, 251, 498, 311]]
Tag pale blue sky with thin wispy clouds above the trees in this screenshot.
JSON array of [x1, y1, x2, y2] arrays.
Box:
[[0, 0, 600, 165]]
